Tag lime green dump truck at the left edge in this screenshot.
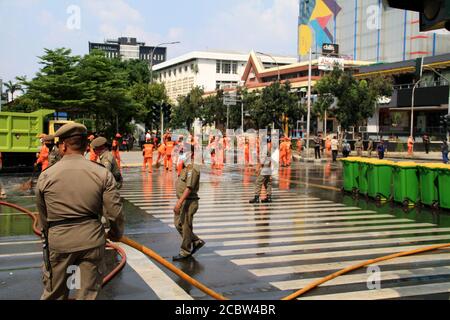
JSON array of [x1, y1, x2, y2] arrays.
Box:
[[0, 109, 72, 169]]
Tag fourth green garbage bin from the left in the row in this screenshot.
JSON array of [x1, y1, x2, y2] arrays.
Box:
[[392, 162, 420, 206]]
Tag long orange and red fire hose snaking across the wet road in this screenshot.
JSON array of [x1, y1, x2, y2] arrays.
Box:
[[0, 201, 450, 300]]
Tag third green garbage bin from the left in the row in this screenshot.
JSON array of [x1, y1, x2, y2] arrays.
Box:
[[367, 160, 394, 200]]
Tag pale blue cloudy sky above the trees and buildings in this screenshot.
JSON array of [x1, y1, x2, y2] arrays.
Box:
[[0, 0, 298, 82]]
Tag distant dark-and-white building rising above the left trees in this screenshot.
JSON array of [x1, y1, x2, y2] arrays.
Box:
[[89, 37, 167, 65]]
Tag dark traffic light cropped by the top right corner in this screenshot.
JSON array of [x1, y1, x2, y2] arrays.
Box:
[[387, 0, 450, 31]]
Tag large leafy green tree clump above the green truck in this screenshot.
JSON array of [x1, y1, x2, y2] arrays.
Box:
[[11, 48, 168, 135]]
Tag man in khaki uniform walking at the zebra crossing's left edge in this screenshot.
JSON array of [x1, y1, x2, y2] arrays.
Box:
[[173, 148, 205, 261]]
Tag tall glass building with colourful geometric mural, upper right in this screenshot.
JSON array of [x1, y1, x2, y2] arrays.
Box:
[[298, 0, 450, 62]]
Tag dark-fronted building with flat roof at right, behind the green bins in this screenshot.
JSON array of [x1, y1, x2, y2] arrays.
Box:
[[356, 53, 450, 141]]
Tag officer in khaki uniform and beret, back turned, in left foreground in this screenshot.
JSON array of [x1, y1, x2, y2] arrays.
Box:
[[36, 123, 124, 300]]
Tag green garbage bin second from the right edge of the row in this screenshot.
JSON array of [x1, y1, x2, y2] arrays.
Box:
[[417, 163, 440, 208]]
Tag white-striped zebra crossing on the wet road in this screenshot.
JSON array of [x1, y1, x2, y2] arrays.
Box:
[[121, 172, 450, 300]]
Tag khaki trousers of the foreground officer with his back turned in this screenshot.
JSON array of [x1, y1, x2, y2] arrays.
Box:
[[41, 246, 105, 300]]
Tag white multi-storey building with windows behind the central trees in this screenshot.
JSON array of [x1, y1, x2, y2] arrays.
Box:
[[153, 51, 297, 102]]
